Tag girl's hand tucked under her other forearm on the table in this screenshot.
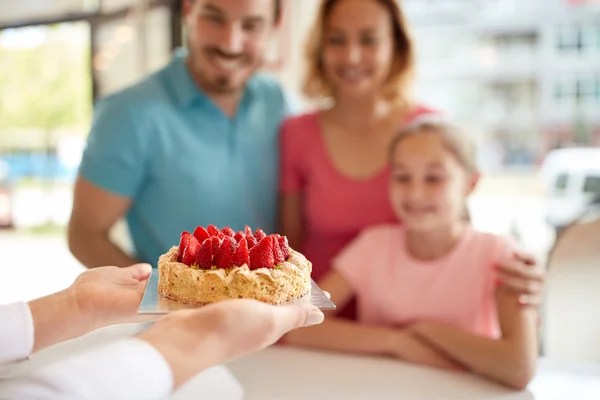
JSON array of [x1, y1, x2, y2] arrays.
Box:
[[392, 328, 462, 370]]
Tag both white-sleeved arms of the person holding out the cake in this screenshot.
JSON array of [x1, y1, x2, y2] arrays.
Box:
[[0, 264, 324, 400]]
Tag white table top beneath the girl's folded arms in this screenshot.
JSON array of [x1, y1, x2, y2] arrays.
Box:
[[0, 324, 600, 400]]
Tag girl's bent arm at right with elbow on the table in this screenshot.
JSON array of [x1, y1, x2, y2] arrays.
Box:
[[411, 288, 538, 389]]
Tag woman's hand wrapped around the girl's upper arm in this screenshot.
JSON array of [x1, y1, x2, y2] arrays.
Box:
[[496, 252, 546, 307]]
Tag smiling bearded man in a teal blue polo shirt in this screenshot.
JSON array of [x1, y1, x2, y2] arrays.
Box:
[[69, 0, 290, 268]]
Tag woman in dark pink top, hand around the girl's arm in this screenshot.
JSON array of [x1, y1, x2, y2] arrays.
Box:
[[279, 0, 543, 319]]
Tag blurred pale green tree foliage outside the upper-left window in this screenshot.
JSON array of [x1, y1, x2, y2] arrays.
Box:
[[0, 25, 92, 149]]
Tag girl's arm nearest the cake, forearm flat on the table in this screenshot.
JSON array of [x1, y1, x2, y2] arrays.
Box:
[[285, 270, 457, 369]]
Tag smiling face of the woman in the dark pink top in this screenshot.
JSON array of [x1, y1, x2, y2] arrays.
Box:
[[322, 0, 394, 98]]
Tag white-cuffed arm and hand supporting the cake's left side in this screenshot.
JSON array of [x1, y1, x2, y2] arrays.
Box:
[[0, 264, 152, 364]]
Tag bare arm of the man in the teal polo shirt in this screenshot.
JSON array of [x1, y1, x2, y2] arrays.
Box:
[[68, 176, 137, 268]]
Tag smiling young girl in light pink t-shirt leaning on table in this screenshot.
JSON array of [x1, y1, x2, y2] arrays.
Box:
[[287, 116, 537, 389]]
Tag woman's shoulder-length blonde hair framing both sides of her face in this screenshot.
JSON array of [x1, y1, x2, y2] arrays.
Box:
[[303, 0, 415, 105]]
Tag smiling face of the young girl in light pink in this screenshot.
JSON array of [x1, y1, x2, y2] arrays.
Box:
[[390, 132, 478, 231]]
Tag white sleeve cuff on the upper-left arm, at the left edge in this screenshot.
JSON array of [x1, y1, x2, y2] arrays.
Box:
[[0, 302, 33, 365]]
